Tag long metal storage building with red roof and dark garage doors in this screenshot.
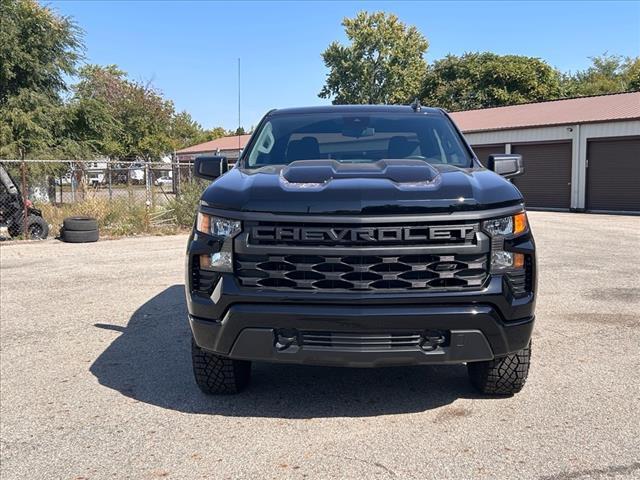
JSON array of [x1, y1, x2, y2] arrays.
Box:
[[451, 92, 640, 213]]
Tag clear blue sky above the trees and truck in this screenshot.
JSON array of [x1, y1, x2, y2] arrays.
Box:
[[47, 1, 640, 128]]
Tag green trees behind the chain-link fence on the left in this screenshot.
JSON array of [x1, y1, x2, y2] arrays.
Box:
[[0, 0, 244, 161]]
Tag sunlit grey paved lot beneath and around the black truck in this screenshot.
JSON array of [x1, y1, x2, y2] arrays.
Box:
[[0, 213, 640, 480]]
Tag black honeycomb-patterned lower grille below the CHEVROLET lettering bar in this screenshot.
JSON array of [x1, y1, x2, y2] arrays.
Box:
[[235, 254, 488, 291]]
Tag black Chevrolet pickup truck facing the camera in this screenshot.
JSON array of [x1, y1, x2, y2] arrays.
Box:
[[186, 104, 536, 395]]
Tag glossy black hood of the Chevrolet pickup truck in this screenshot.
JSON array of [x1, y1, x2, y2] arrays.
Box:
[[202, 160, 523, 215]]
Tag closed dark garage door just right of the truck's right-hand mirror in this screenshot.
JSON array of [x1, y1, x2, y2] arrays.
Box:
[[511, 142, 571, 209]]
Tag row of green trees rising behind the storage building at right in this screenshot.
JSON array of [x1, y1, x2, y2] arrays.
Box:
[[319, 12, 640, 111]]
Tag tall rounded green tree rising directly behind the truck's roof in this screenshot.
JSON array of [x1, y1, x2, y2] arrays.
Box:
[[319, 12, 429, 104]]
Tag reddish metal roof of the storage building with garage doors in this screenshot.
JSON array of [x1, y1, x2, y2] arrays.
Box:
[[451, 92, 640, 133]]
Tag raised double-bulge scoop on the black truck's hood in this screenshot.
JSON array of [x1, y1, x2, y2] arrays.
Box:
[[280, 159, 440, 188]]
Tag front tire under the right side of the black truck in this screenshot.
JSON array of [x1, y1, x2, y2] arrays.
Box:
[[467, 342, 531, 395]]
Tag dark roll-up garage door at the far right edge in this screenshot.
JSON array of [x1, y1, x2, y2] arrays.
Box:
[[587, 138, 640, 212]]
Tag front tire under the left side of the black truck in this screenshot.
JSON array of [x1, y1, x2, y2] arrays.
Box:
[[191, 338, 251, 395]]
